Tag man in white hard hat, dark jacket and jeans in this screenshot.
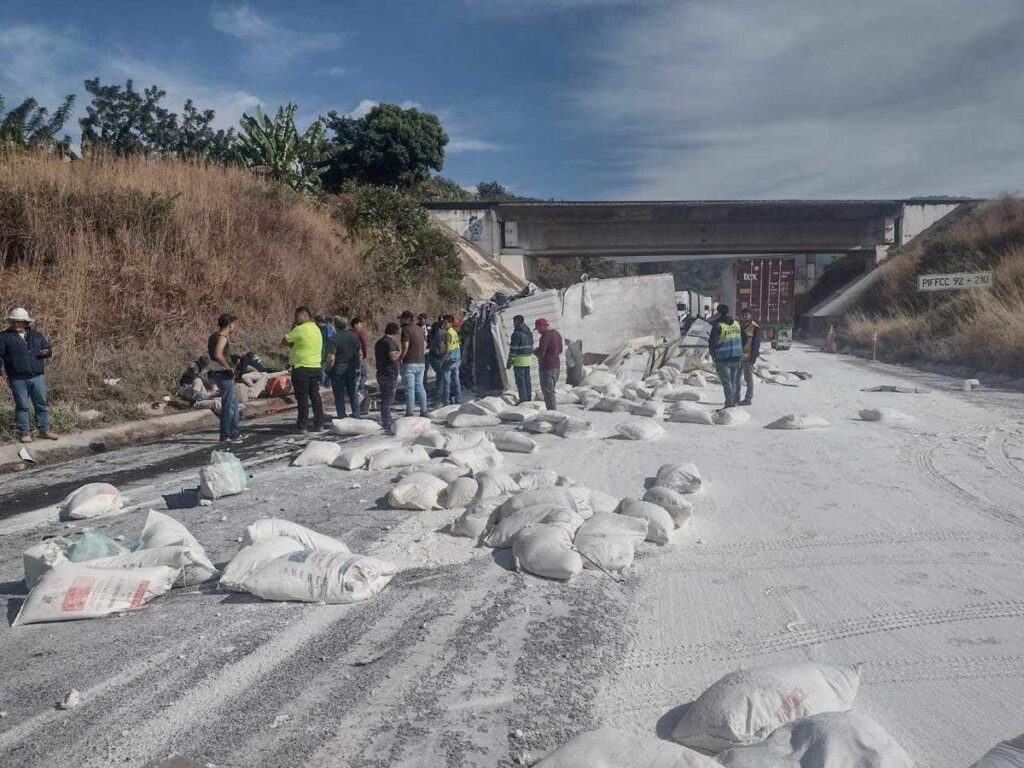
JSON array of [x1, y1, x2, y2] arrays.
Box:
[[0, 307, 56, 442]]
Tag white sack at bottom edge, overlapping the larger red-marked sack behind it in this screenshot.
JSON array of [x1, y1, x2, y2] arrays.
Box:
[[718, 712, 913, 768]]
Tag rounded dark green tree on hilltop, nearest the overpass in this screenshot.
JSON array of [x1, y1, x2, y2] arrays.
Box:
[[325, 104, 447, 191]]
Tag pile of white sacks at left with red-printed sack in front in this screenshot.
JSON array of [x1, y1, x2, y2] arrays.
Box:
[[13, 510, 218, 625]]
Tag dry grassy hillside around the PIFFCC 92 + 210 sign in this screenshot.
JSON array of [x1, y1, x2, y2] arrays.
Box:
[[847, 198, 1024, 376]]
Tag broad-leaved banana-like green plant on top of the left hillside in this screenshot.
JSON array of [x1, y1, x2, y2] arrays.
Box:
[[236, 103, 327, 194]]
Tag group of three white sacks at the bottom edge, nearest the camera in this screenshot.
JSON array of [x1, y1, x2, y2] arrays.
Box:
[[535, 662, 912, 768]]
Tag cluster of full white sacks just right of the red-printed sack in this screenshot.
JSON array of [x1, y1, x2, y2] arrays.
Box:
[[220, 517, 397, 605]]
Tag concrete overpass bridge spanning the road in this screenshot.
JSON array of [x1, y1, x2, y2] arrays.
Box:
[[426, 198, 973, 279]]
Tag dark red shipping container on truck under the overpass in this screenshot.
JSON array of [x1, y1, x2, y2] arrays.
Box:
[[735, 259, 797, 349]]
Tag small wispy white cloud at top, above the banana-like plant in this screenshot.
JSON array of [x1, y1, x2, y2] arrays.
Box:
[[210, 3, 344, 71]]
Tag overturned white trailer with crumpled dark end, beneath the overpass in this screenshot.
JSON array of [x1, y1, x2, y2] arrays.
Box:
[[462, 274, 679, 392]]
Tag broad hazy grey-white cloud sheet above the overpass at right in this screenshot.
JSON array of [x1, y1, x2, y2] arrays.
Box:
[[575, 0, 1024, 198]]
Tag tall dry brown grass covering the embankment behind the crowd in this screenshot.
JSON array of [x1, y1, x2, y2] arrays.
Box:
[[0, 155, 448, 415]]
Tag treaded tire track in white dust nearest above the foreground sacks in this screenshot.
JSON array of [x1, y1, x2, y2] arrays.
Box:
[[625, 600, 1024, 669]]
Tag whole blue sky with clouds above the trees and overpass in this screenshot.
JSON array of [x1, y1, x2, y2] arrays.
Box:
[[0, 0, 1024, 199]]
